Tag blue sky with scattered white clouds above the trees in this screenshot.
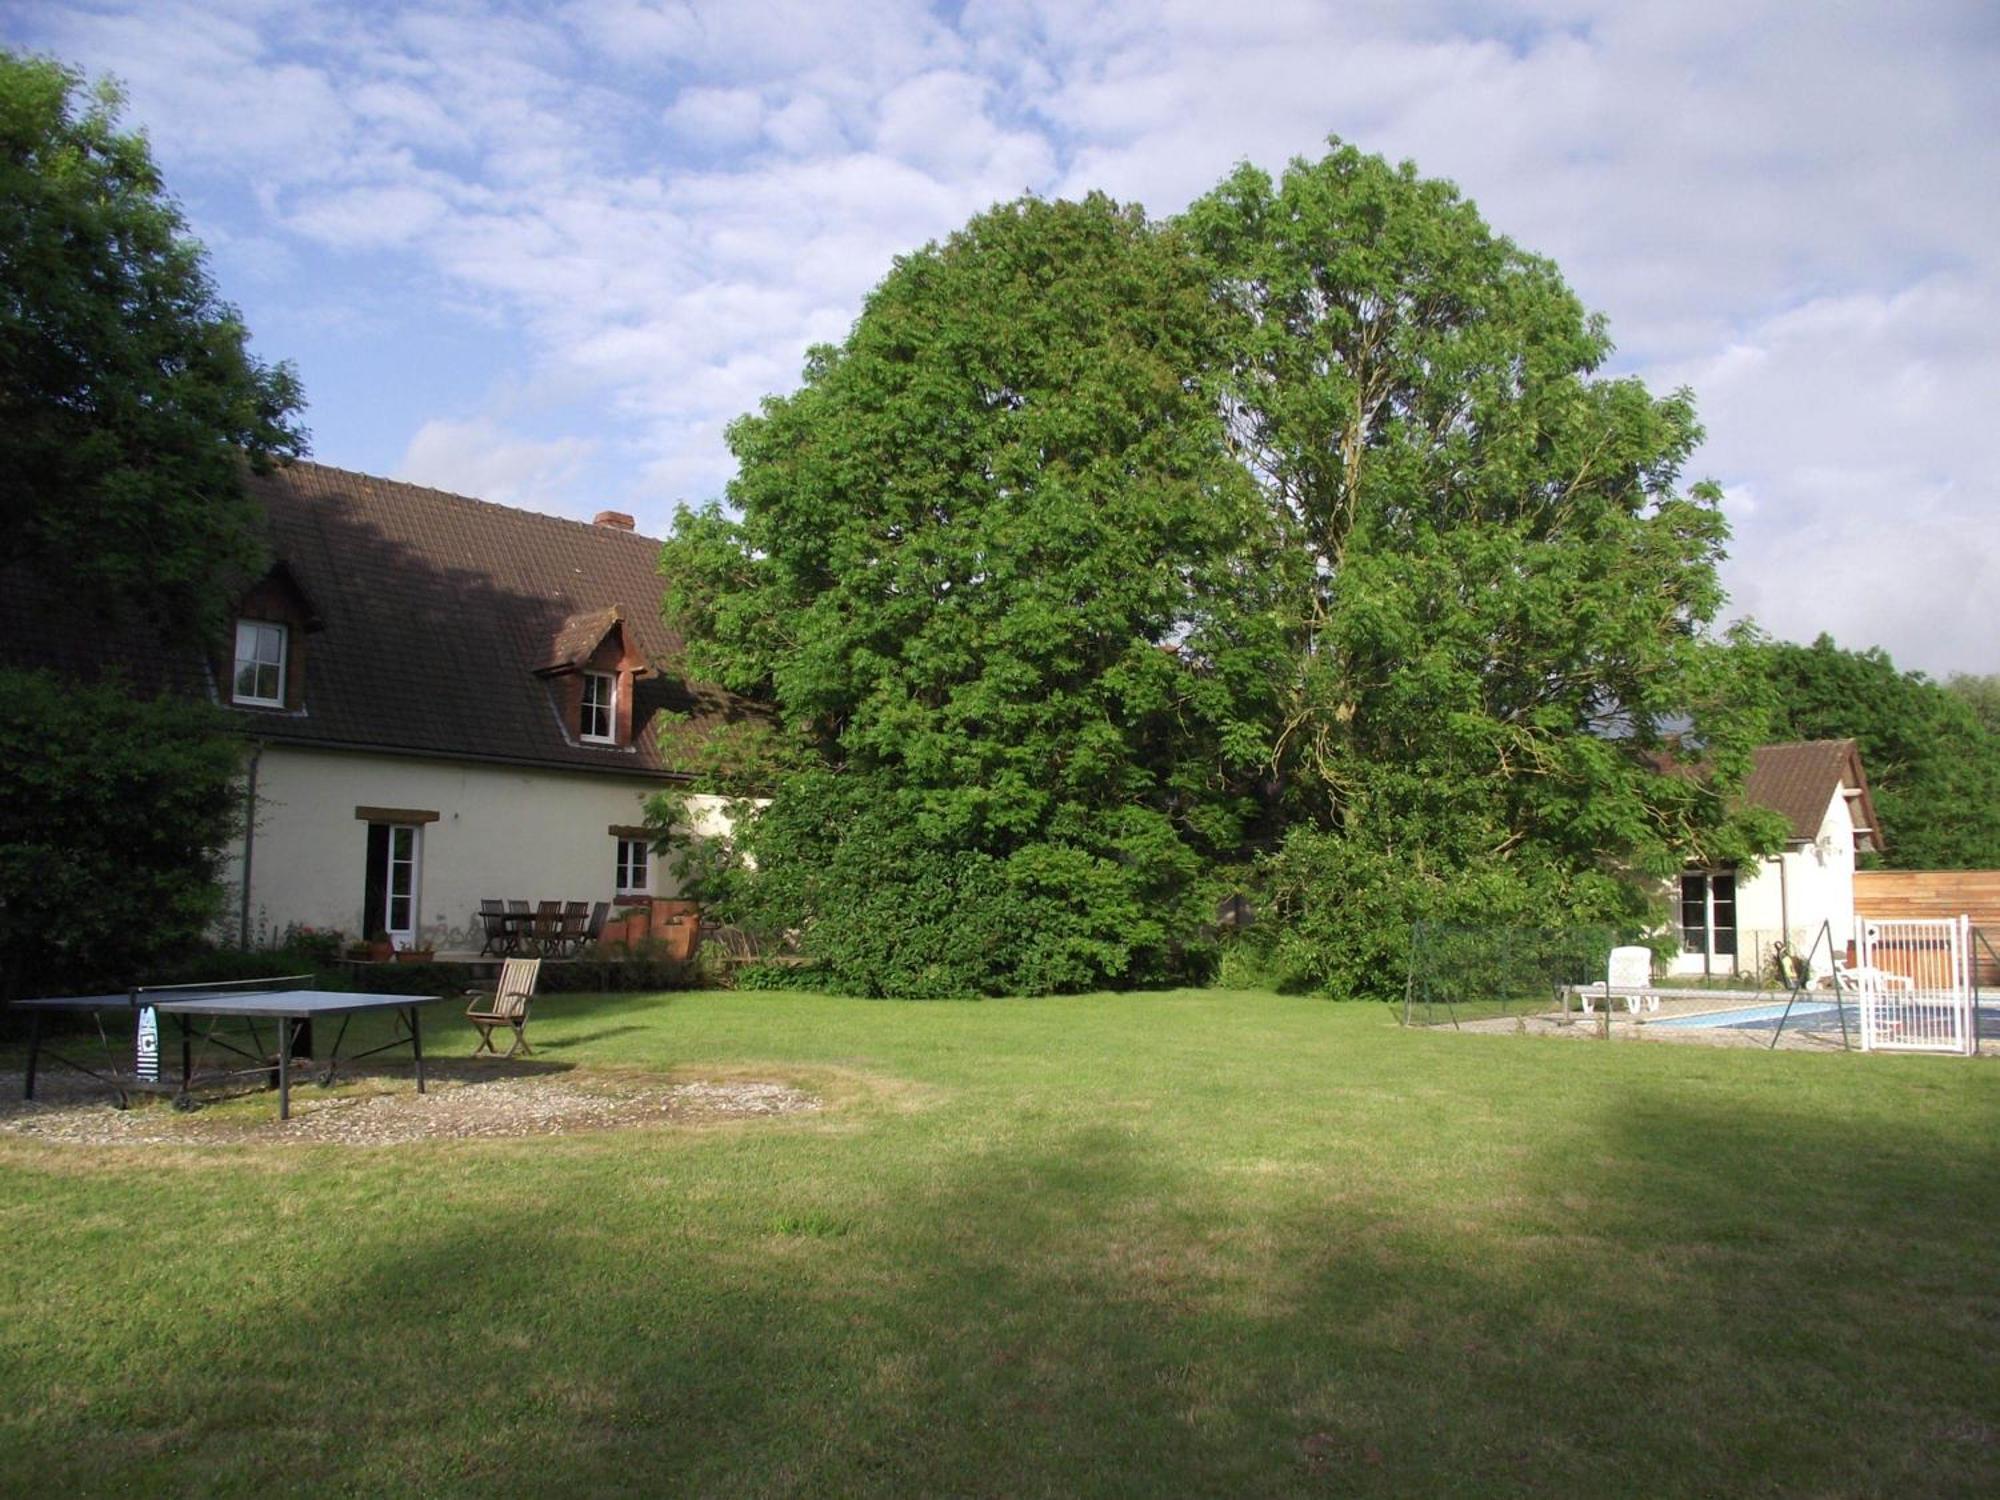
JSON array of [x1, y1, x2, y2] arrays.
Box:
[[0, 0, 2000, 678]]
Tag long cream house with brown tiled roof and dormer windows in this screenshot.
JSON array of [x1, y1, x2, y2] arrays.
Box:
[[0, 462, 756, 950]]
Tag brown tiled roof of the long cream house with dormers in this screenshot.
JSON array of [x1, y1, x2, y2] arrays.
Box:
[[0, 462, 760, 776]]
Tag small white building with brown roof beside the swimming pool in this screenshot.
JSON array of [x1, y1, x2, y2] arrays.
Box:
[[1670, 740, 1882, 978]]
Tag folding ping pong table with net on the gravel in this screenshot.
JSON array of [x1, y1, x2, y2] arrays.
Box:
[[14, 974, 444, 1120]]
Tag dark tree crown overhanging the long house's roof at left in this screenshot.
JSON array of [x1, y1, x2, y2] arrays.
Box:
[[0, 52, 306, 638]]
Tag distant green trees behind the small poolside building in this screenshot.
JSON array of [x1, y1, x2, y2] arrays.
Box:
[[1744, 636, 2000, 870]]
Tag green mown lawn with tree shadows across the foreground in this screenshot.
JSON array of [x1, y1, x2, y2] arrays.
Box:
[[0, 992, 2000, 1496]]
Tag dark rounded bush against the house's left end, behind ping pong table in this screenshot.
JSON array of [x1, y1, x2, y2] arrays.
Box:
[[0, 672, 242, 994]]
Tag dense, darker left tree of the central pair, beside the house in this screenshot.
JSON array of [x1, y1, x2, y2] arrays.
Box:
[[662, 196, 1270, 994]]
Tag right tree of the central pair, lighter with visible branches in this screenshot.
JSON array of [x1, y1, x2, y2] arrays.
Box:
[[1186, 144, 1770, 994]]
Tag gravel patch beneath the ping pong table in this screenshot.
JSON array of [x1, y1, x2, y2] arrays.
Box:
[[0, 1068, 822, 1146]]
